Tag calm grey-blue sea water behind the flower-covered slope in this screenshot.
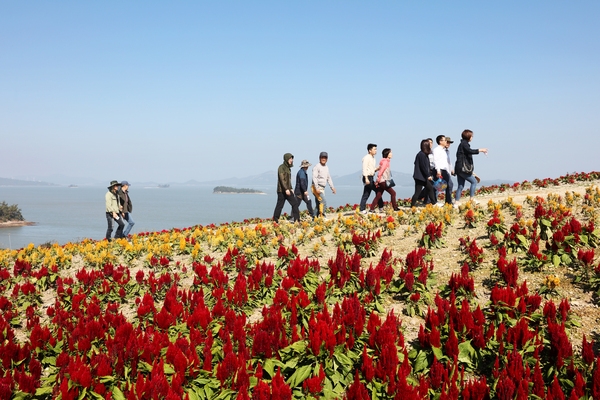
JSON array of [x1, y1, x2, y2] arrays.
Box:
[[0, 185, 412, 249]]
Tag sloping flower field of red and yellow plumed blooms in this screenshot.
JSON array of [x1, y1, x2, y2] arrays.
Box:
[[0, 172, 600, 400]]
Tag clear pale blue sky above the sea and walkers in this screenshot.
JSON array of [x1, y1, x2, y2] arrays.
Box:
[[0, 0, 600, 182]]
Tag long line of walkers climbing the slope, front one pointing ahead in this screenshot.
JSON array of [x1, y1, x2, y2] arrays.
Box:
[[273, 129, 488, 222]]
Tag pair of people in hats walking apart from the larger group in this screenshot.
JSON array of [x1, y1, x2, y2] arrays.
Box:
[[104, 181, 135, 241]]
